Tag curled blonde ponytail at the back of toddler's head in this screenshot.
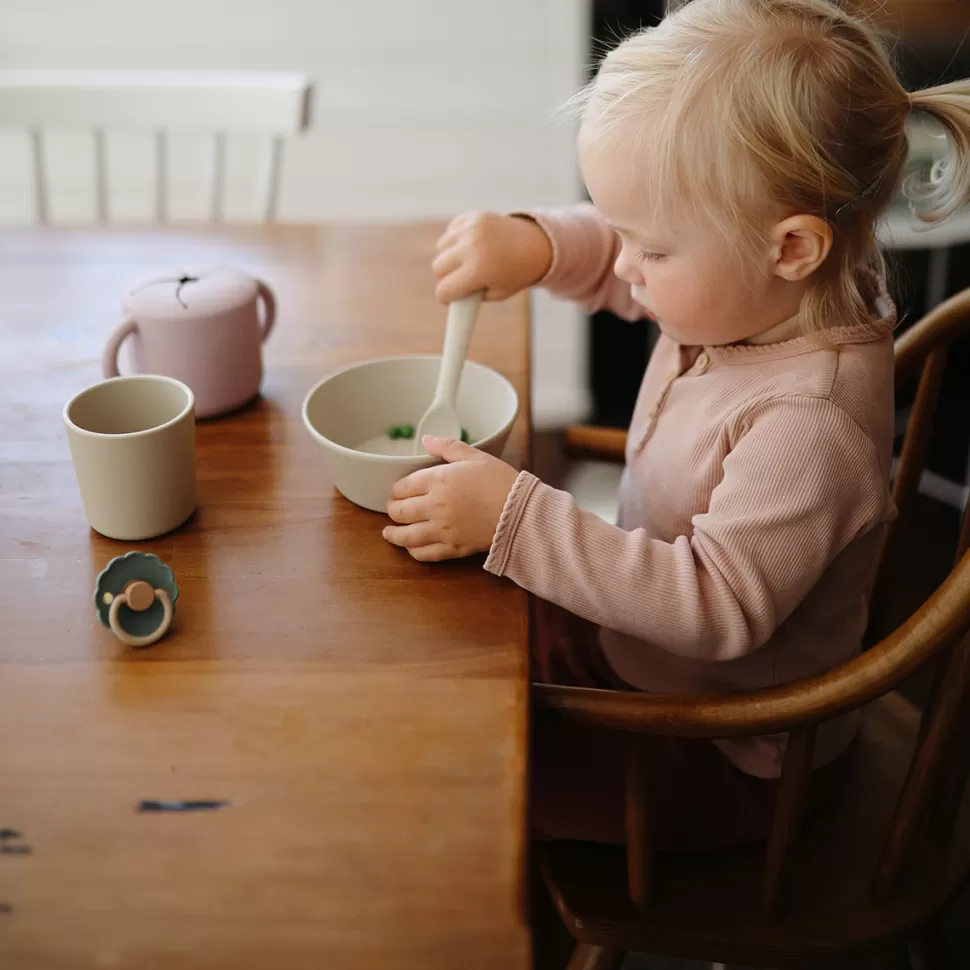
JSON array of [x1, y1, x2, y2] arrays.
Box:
[[903, 81, 970, 222]]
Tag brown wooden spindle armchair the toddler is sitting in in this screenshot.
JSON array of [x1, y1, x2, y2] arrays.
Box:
[[534, 290, 970, 970]]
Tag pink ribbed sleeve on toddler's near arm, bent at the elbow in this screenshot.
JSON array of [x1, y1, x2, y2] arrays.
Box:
[[485, 397, 892, 661]]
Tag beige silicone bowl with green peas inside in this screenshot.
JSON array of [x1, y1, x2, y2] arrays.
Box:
[[303, 356, 519, 512]]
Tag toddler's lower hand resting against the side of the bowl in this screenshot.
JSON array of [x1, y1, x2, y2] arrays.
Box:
[[384, 437, 519, 562]]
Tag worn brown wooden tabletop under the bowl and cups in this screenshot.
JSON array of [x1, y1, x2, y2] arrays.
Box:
[[0, 225, 529, 970]]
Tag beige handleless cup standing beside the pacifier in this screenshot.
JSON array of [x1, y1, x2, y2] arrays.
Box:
[[64, 374, 195, 540]]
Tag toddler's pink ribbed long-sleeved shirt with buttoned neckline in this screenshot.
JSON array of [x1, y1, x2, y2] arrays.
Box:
[[485, 206, 894, 777]]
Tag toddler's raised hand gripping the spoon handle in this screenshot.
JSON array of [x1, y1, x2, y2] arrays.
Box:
[[431, 212, 552, 303]]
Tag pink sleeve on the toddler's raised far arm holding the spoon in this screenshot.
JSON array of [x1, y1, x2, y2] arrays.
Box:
[[515, 203, 645, 321]]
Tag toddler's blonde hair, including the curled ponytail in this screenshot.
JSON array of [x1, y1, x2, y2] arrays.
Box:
[[571, 0, 970, 332]]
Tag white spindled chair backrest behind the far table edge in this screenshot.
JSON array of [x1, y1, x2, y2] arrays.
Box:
[[0, 70, 311, 224]]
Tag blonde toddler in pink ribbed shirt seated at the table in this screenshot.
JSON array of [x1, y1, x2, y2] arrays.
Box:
[[385, 0, 970, 847]]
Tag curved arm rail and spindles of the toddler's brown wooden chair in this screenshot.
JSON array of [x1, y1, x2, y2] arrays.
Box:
[[536, 290, 970, 916]]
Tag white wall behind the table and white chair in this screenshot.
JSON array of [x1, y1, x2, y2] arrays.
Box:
[[0, 0, 589, 423]]
